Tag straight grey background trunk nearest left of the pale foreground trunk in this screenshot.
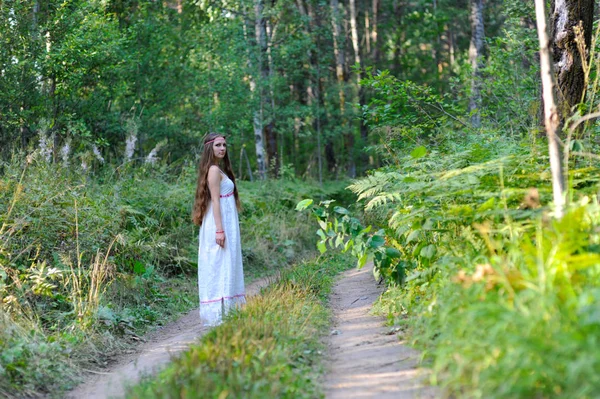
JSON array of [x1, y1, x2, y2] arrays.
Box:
[[469, 0, 484, 128]]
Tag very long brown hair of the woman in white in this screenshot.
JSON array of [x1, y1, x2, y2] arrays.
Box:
[[192, 133, 240, 226]]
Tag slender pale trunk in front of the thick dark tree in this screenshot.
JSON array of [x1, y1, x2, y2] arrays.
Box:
[[535, 0, 565, 219]]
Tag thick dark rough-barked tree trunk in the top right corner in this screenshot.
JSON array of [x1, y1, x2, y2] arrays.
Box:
[[550, 0, 594, 120]]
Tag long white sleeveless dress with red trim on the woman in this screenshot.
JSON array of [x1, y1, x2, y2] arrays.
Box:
[[198, 172, 246, 326]]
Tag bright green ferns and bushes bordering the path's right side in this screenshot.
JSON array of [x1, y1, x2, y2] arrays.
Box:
[[313, 133, 600, 398]]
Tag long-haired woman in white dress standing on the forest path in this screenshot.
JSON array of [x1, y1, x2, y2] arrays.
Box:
[[192, 133, 246, 326]]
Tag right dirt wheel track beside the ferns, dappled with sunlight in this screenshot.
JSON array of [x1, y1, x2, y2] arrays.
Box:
[[325, 264, 440, 399]]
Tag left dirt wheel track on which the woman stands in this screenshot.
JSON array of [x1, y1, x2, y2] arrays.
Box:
[[66, 278, 273, 399]]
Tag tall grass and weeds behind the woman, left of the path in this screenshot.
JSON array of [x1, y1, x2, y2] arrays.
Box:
[[0, 156, 347, 397]]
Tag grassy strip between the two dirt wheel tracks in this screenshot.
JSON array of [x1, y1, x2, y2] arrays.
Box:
[[127, 255, 353, 399]]
